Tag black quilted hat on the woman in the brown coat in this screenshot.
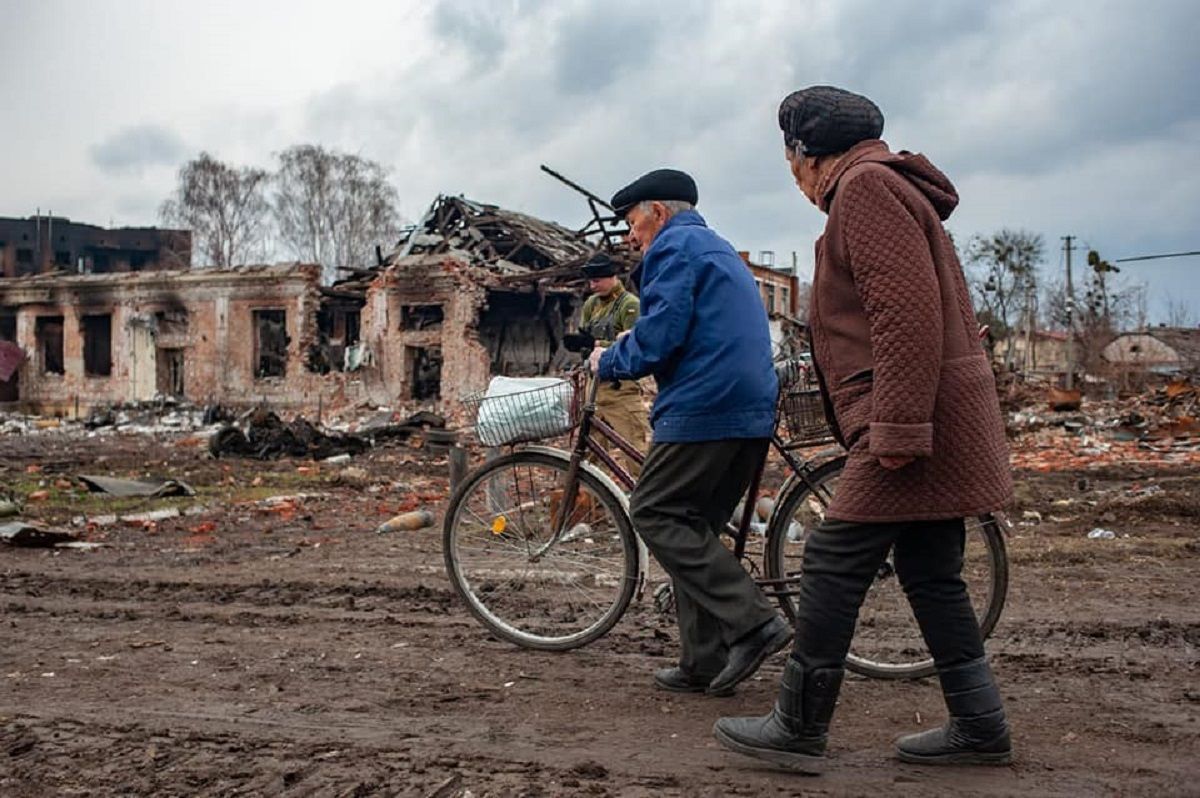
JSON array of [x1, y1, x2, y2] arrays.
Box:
[[779, 86, 883, 155]]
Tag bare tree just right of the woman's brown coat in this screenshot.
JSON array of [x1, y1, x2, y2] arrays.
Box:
[[966, 229, 1045, 364]]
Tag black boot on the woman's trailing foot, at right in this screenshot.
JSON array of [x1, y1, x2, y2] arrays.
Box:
[[896, 658, 1013, 764]]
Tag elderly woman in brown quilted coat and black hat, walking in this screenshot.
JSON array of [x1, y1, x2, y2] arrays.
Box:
[[714, 86, 1012, 773]]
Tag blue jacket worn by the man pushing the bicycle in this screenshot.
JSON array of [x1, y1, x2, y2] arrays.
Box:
[[599, 211, 779, 443]]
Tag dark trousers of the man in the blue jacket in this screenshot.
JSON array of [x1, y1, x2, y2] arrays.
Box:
[[630, 438, 775, 676]]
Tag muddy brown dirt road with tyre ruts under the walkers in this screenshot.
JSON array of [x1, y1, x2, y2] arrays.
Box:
[[0, 436, 1200, 798]]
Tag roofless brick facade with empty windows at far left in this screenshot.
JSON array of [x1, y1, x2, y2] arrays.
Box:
[[0, 266, 328, 412]]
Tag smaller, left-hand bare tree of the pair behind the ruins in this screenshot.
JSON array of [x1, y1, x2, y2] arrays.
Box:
[[158, 152, 269, 268]]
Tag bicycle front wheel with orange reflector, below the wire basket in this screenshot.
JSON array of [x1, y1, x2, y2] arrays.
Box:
[[443, 451, 637, 650]]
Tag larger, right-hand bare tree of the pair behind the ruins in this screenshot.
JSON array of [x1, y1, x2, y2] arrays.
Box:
[[272, 144, 400, 282]]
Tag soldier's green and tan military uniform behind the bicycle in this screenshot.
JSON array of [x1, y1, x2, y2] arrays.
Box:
[[580, 283, 650, 476]]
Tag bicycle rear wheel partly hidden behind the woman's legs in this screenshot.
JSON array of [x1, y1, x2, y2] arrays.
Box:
[[763, 457, 1008, 679]]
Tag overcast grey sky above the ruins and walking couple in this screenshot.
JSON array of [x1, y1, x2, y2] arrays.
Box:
[[0, 0, 1200, 324]]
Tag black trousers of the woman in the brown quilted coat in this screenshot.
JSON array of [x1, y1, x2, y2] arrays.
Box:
[[792, 518, 983, 670]]
